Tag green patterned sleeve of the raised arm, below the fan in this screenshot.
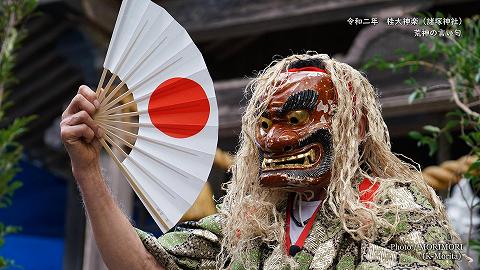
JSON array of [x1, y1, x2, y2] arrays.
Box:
[[136, 214, 222, 270]]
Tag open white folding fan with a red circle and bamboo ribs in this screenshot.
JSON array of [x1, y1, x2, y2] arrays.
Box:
[[94, 0, 218, 232]]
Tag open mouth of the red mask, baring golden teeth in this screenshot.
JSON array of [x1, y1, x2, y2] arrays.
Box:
[[262, 146, 320, 172]]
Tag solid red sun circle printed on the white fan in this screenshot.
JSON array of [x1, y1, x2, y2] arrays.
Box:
[[148, 78, 210, 138]]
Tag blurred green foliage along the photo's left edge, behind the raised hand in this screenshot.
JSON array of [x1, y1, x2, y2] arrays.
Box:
[[0, 0, 37, 269]]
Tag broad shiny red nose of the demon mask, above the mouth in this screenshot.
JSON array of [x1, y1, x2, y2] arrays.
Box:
[[265, 125, 298, 154]]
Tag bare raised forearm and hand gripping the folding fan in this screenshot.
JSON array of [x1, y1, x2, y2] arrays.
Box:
[[60, 86, 163, 269]]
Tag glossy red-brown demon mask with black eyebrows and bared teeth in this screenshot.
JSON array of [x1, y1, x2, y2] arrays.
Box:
[[256, 67, 337, 191]]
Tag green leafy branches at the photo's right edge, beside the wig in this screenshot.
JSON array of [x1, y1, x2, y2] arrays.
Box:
[[364, 13, 480, 258]]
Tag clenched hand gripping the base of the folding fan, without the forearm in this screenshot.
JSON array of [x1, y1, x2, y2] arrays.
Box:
[[60, 85, 102, 175]]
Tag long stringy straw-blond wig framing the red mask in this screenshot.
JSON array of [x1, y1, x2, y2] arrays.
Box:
[[218, 52, 455, 269]]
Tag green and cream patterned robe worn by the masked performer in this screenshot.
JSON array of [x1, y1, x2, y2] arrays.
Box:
[[137, 184, 461, 270]]
